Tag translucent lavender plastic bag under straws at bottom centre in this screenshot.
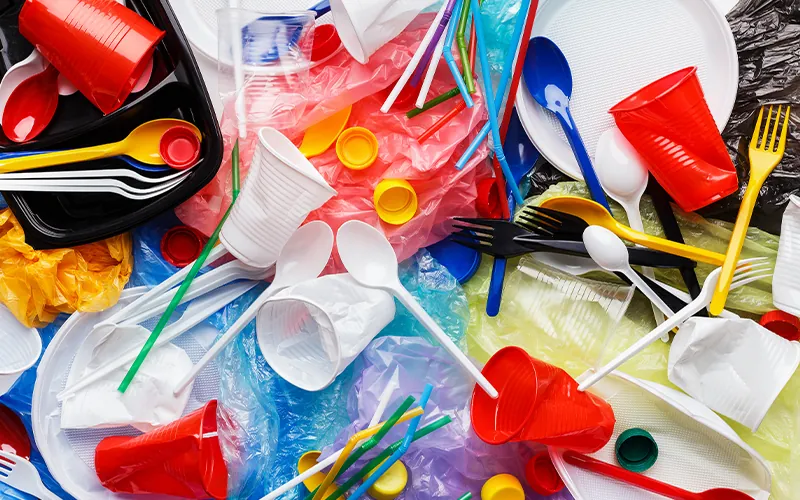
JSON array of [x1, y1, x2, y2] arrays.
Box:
[[323, 336, 572, 500]]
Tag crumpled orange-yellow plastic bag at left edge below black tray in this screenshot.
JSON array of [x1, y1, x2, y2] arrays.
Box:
[[0, 209, 133, 328]]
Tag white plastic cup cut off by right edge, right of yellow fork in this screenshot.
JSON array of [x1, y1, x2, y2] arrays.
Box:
[[772, 195, 800, 316]]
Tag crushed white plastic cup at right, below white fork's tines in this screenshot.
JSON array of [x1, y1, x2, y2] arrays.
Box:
[[668, 318, 800, 432]]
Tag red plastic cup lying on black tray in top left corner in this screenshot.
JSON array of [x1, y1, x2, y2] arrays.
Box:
[[19, 0, 165, 114]]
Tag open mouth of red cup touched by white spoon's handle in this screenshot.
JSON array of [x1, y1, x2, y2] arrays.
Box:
[[470, 346, 537, 445]]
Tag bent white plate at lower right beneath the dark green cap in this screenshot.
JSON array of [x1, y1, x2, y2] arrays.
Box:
[[550, 372, 772, 500]]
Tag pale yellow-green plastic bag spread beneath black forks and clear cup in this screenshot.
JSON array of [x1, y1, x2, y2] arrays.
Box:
[[465, 187, 800, 500]]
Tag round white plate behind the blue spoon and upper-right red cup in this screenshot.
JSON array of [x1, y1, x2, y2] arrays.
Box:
[[516, 0, 739, 180]]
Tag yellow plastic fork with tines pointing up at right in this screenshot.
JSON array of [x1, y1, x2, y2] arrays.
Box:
[[709, 106, 792, 316]]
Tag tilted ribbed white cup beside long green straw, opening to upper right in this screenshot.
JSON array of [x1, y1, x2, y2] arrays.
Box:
[[220, 127, 336, 269]]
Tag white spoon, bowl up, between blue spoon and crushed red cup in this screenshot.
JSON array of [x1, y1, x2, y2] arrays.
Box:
[[594, 127, 669, 328]]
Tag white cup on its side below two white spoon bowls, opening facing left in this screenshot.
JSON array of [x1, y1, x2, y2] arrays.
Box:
[[256, 274, 395, 391]]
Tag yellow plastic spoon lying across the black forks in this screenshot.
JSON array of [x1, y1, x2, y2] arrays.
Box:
[[542, 196, 725, 266]]
